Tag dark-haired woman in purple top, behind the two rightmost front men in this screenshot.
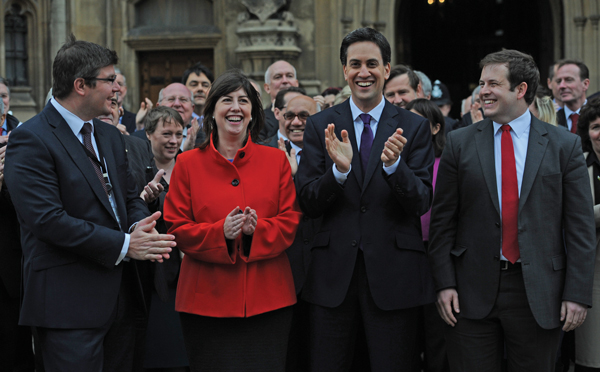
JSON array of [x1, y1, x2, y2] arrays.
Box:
[[406, 98, 450, 372]]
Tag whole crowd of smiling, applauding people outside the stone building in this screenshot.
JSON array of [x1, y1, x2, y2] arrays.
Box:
[[0, 28, 600, 372]]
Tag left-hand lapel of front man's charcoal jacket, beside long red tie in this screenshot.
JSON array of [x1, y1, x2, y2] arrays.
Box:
[[475, 119, 500, 215]]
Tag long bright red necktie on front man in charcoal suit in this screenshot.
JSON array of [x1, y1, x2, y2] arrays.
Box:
[[501, 125, 519, 263]]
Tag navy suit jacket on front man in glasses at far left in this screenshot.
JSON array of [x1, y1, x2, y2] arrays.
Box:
[[6, 103, 149, 328]]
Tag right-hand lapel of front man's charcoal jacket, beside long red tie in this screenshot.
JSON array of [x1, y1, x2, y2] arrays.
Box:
[[519, 115, 548, 212]]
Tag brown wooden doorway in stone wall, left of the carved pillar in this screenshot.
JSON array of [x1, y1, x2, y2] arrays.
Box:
[[138, 49, 214, 104]]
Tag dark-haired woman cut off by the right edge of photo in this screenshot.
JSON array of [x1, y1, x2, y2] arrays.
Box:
[[575, 98, 600, 372]]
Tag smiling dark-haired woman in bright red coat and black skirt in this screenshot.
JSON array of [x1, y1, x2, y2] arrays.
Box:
[[164, 71, 300, 371]]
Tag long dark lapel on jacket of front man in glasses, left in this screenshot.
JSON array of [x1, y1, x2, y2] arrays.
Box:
[[44, 103, 114, 218]]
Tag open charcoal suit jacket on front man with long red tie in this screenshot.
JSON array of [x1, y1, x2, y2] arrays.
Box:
[[429, 115, 596, 329]]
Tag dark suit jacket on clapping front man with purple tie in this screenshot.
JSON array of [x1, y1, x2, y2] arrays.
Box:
[[296, 101, 435, 310]]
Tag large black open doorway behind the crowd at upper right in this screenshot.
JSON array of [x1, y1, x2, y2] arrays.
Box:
[[396, 0, 554, 118]]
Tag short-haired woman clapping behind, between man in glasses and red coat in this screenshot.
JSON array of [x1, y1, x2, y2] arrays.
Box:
[[141, 106, 188, 372]]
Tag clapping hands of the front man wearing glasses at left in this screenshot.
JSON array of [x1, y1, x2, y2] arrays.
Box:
[[127, 212, 177, 262]]
